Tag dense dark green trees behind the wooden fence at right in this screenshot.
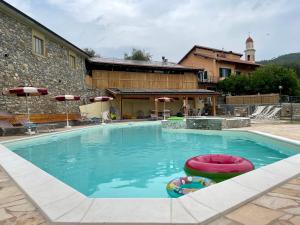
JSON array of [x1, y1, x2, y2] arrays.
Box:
[[218, 65, 300, 95]]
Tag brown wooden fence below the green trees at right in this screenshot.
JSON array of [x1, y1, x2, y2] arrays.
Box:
[[226, 94, 279, 105]]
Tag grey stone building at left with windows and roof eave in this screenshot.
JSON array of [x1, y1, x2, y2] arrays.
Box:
[[0, 0, 88, 113]]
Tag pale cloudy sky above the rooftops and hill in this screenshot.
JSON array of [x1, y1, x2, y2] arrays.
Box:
[[6, 0, 300, 62]]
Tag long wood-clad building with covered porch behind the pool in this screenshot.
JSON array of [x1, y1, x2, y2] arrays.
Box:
[[86, 57, 218, 119]]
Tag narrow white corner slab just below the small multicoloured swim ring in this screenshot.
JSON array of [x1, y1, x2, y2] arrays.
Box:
[[178, 196, 219, 223]]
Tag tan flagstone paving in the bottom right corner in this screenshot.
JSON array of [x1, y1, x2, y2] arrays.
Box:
[[209, 176, 300, 225]]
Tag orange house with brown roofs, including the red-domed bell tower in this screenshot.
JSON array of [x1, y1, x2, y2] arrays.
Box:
[[179, 37, 260, 89]]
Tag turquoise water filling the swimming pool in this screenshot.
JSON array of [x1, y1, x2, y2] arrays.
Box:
[[5, 123, 296, 198]]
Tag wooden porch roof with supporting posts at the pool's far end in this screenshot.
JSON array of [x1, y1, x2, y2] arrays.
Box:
[[107, 88, 219, 116]]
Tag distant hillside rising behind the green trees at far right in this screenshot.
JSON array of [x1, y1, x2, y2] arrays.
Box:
[[258, 52, 300, 78]]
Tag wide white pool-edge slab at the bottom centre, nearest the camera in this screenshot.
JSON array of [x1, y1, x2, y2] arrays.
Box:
[[81, 198, 171, 225]]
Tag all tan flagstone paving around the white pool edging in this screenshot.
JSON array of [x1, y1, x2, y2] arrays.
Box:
[[0, 124, 300, 225]]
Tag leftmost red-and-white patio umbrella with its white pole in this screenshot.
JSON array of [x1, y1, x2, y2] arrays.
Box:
[[3, 87, 48, 122]]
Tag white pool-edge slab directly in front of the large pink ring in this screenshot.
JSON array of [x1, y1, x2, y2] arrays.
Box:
[[187, 180, 259, 213]]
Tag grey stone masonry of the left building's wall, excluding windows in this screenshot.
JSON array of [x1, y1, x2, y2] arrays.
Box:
[[0, 12, 93, 113]]
